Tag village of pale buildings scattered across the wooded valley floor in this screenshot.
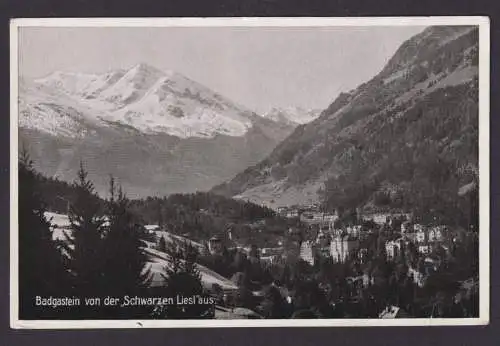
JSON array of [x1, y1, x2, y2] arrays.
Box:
[[135, 200, 478, 318]]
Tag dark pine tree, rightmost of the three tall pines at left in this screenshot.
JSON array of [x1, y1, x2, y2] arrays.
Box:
[[102, 177, 151, 297]]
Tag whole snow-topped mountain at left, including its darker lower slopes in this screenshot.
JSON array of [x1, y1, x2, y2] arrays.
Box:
[[19, 64, 293, 196]]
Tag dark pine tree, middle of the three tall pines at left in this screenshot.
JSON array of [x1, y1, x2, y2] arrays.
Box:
[[66, 163, 105, 297]]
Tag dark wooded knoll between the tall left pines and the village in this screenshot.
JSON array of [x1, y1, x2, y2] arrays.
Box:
[[131, 192, 289, 247]]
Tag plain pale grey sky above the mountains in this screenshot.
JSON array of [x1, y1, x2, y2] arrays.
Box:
[[19, 26, 424, 112]]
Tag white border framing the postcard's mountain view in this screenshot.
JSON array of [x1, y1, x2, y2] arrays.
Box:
[[10, 16, 490, 329]]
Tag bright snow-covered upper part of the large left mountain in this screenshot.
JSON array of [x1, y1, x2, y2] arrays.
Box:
[[20, 64, 254, 138]]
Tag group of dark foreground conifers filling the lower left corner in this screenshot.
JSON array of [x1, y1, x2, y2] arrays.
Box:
[[18, 152, 211, 319]]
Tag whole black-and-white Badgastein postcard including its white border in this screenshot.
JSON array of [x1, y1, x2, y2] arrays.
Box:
[[10, 17, 490, 329]]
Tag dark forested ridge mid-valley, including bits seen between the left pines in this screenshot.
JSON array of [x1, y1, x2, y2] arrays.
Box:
[[31, 166, 290, 246]]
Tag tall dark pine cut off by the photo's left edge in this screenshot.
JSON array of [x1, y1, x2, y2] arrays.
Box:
[[18, 150, 69, 319]]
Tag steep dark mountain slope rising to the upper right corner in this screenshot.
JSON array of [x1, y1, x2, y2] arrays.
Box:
[[213, 26, 478, 224]]
